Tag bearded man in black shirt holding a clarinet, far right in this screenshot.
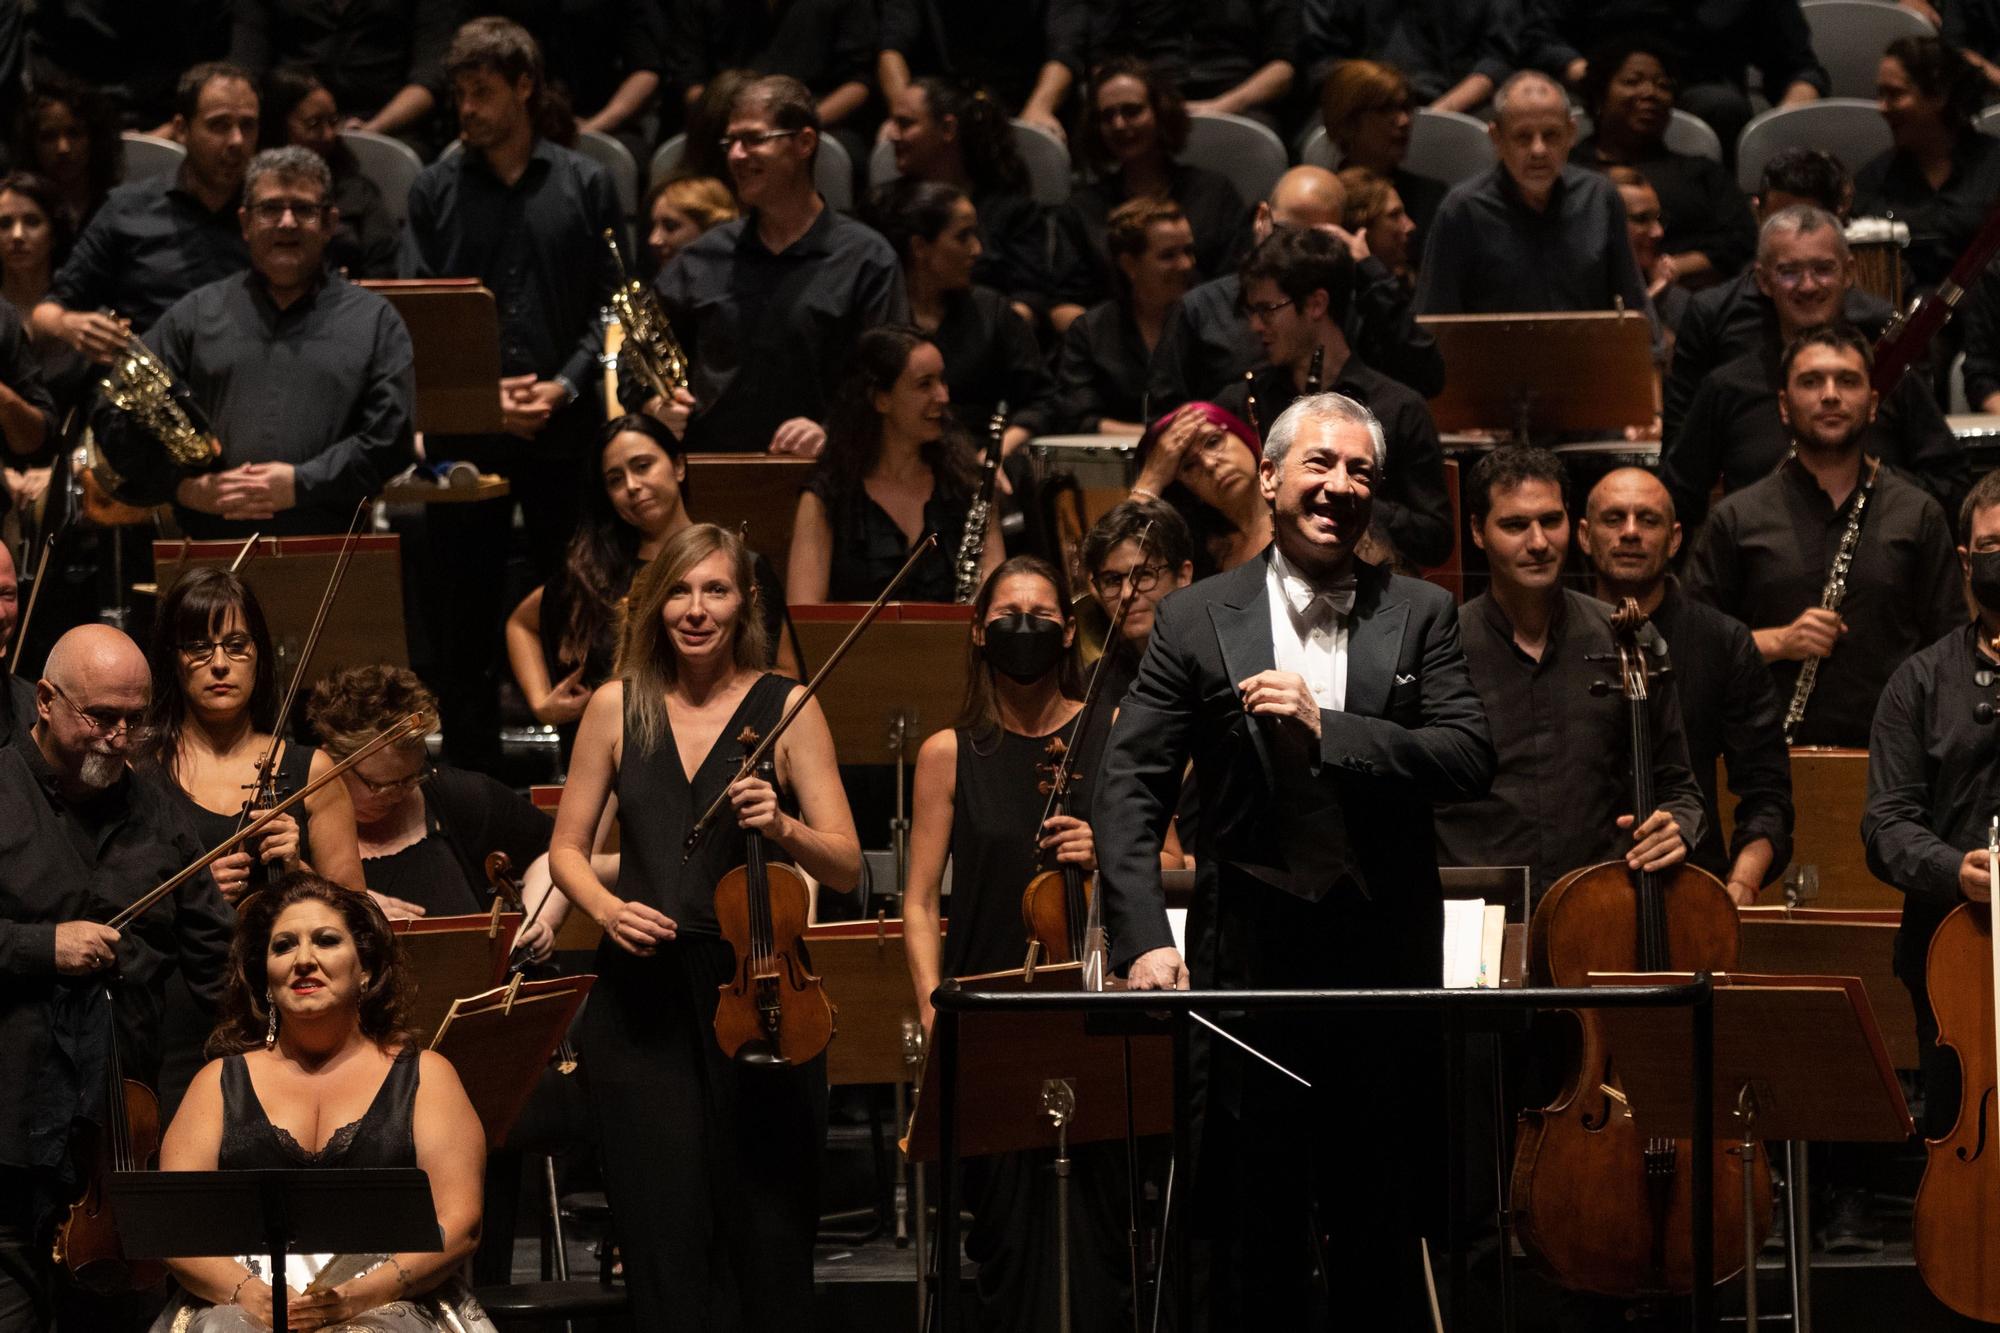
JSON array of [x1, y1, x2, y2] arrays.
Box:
[[1688, 328, 1962, 747]]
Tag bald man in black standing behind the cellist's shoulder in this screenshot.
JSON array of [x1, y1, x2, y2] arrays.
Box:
[[1576, 468, 1792, 905]]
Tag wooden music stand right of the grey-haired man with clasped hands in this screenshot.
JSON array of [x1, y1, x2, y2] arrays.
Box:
[[360, 278, 500, 434]]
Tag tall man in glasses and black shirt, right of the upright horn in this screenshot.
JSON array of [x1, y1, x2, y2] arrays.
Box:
[[640, 76, 910, 458]]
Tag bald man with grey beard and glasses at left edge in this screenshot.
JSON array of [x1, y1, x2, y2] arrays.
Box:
[[0, 624, 234, 1333]]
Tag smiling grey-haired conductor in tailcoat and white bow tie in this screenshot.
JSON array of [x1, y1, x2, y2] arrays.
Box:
[[1092, 394, 1494, 1329]]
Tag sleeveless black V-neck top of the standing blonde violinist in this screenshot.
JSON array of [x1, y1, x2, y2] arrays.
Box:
[[606, 673, 798, 943]]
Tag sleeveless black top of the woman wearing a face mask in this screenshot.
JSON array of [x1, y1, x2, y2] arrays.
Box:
[[944, 719, 1074, 977]]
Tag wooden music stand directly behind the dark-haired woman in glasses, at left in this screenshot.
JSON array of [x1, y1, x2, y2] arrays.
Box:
[[152, 532, 410, 685]]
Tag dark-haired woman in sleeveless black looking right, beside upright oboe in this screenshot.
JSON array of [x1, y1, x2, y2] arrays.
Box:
[[784, 324, 1002, 602]]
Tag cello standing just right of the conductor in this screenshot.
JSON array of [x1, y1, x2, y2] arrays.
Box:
[[1510, 598, 1772, 1299]]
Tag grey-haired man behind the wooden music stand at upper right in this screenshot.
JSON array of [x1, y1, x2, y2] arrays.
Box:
[[1416, 70, 1652, 316]]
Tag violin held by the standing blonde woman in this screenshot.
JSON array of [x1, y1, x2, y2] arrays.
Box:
[[716, 748, 834, 1067]]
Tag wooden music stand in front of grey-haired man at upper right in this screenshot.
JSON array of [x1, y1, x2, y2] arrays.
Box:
[[1418, 310, 1654, 440]]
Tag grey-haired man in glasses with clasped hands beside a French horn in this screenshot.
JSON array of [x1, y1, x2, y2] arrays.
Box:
[[96, 146, 416, 538]]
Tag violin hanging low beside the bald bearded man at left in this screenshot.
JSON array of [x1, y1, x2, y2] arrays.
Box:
[[54, 987, 166, 1295]]
